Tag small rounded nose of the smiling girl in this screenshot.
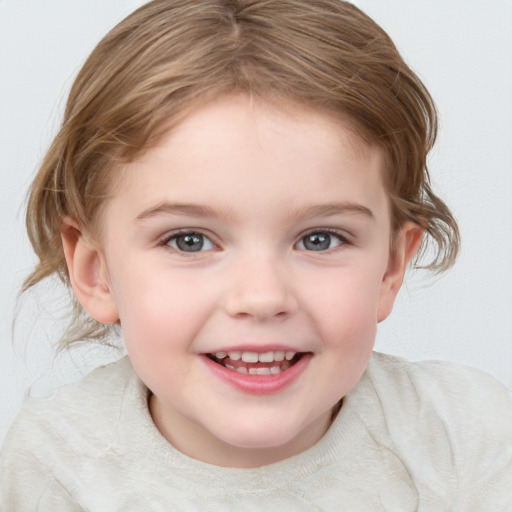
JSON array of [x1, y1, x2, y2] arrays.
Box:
[[225, 256, 298, 321]]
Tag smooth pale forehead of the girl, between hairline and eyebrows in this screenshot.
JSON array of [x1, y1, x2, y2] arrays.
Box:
[[106, 96, 390, 226]]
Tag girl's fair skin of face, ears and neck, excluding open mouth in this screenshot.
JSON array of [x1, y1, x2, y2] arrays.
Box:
[[62, 96, 421, 467]]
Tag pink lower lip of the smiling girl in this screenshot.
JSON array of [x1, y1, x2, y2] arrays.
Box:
[[202, 354, 312, 395]]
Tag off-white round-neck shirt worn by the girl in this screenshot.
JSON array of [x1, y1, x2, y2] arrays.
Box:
[[0, 353, 512, 512]]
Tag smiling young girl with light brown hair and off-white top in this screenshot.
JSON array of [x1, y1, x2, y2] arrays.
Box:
[[0, 0, 512, 511]]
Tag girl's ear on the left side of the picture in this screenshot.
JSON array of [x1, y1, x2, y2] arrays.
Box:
[[60, 218, 119, 324]]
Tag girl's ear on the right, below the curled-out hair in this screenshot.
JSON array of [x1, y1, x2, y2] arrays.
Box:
[[377, 222, 423, 322]]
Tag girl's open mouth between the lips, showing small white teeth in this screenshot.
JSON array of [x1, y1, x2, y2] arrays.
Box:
[[206, 350, 305, 375]]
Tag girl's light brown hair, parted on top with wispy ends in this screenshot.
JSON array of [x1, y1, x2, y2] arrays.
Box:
[[23, 0, 459, 343]]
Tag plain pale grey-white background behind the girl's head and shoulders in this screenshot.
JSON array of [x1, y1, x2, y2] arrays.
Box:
[[0, 0, 512, 443]]
